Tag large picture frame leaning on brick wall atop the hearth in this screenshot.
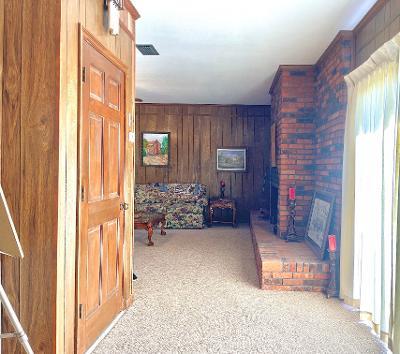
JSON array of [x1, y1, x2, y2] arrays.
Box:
[[305, 191, 335, 260]]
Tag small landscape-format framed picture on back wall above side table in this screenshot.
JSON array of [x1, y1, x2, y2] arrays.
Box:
[[217, 147, 247, 172]]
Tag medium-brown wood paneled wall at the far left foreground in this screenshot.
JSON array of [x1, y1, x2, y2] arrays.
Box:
[[0, 0, 61, 353]]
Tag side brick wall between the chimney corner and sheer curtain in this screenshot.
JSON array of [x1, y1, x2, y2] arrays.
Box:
[[315, 31, 354, 241]]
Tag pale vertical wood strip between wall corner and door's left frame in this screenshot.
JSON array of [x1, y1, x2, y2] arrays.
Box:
[[57, 0, 80, 353]]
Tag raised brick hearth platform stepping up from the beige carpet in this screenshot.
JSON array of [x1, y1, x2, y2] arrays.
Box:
[[250, 211, 330, 292]]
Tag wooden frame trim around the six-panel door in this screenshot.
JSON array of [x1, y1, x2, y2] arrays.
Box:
[[74, 24, 130, 352]]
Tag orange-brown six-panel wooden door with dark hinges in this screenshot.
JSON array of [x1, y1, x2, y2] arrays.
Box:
[[77, 34, 125, 352]]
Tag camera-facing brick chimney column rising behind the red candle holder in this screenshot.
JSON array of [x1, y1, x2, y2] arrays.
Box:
[[271, 65, 315, 236]]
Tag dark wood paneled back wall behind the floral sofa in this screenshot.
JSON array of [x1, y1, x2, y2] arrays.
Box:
[[136, 104, 270, 220]]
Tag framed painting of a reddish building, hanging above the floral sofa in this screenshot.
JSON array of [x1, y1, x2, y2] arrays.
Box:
[[142, 132, 170, 167]]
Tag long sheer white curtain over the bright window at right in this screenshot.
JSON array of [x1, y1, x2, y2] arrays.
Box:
[[341, 35, 400, 347]]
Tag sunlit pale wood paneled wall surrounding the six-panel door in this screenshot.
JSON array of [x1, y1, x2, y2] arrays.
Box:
[[57, 0, 135, 353]]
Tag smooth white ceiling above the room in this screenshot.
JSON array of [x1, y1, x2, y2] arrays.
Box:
[[134, 0, 376, 104]]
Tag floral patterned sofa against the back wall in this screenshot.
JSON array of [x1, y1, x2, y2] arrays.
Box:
[[135, 183, 208, 229]]
